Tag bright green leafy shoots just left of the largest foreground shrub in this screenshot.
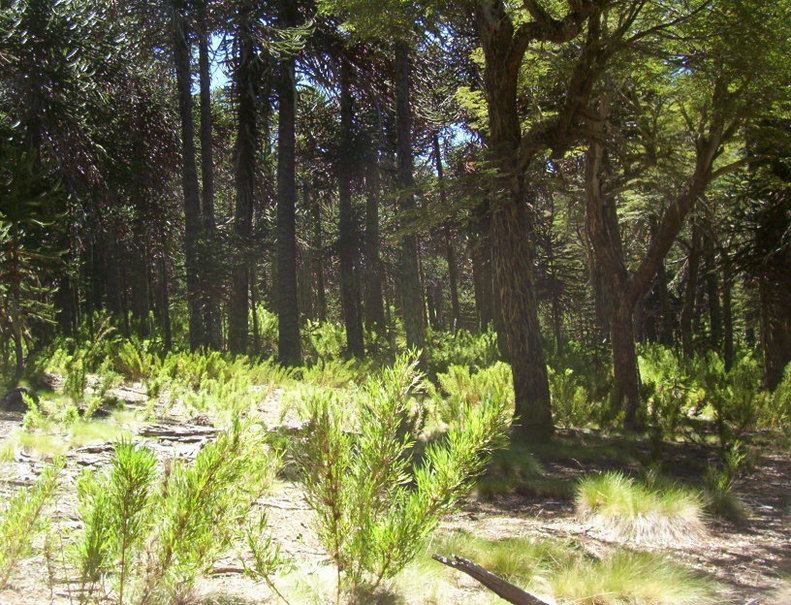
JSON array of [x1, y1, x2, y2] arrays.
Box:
[[74, 422, 282, 605]]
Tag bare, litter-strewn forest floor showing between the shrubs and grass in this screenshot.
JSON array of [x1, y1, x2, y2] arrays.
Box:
[[0, 387, 791, 605]]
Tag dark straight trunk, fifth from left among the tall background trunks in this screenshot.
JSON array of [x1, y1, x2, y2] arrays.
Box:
[[338, 59, 365, 357]]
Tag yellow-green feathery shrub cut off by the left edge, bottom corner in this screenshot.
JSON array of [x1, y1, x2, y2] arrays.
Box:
[[0, 460, 63, 589]]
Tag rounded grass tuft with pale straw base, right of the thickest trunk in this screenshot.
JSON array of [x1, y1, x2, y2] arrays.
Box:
[[575, 472, 704, 543]]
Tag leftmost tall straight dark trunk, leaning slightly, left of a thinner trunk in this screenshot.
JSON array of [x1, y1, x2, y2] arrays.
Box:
[[172, 5, 206, 350]]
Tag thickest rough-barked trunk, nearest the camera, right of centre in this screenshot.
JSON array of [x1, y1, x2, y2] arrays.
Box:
[[478, 3, 554, 439]]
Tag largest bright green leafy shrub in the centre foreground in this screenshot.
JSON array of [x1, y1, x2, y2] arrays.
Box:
[[295, 358, 508, 598]]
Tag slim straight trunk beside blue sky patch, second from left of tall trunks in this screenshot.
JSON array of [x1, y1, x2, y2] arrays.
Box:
[[198, 1, 222, 349]]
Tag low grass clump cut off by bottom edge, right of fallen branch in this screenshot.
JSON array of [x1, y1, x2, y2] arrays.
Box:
[[549, 552, 715, 605]]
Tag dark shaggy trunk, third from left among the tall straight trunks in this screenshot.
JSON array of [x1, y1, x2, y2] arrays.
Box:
[[228, 8, 258, 353]]
